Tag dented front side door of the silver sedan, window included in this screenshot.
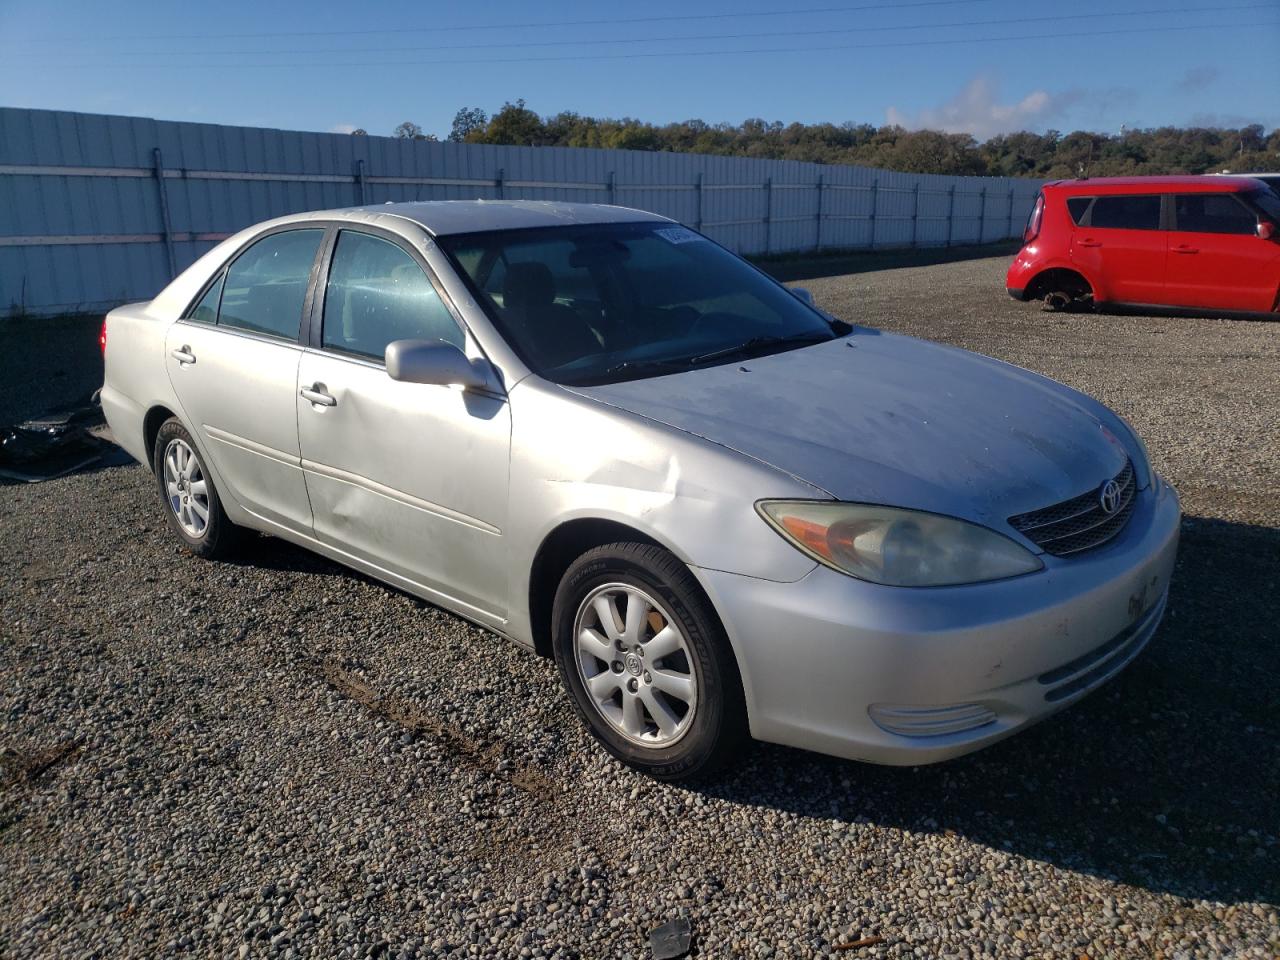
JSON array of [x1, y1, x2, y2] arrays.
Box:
[[296, 230, 511, 621]]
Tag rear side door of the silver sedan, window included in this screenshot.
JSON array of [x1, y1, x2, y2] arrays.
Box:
[[165, 228, 325, 534]]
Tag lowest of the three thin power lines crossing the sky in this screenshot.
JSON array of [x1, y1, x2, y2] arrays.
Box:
[[24, 20, 1280, 70]]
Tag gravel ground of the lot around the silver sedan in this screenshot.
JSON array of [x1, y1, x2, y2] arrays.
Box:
[[0, 257, 1280, 960]]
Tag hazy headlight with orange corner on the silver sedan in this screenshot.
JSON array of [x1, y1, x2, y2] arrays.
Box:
[[756, 500, 1044, 586]]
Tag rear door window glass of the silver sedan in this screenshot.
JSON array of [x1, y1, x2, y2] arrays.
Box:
[[218, 229, 324, 340]]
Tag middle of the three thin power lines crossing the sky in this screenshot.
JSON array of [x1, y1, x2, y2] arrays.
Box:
[[12, 3, 1259, 60]]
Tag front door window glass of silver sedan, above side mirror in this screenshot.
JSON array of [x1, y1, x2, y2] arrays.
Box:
[[323, 230, 466, 360]]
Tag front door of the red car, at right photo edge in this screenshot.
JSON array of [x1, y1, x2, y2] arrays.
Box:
[[1167, 193, 1280, 312]]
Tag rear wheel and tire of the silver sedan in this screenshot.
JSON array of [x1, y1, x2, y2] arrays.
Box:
[[151, 417, 242, 559]]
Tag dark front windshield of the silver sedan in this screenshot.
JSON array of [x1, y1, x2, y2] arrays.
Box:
[[440, 223, 846, 385]]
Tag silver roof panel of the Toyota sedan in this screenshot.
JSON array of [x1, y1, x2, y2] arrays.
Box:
[[271, 200, 671, 237]]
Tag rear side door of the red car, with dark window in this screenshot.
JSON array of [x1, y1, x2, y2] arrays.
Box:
[[1071, 193, 1169, 303]]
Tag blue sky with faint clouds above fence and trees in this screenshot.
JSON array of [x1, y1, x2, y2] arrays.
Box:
[[0, 0, 1280, 138]]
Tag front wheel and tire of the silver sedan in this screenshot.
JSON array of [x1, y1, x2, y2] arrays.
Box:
[[552, 543, 746, 781]]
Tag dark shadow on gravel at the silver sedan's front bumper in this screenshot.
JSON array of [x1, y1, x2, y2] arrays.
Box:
[[699, 517, 1280, 904]]
